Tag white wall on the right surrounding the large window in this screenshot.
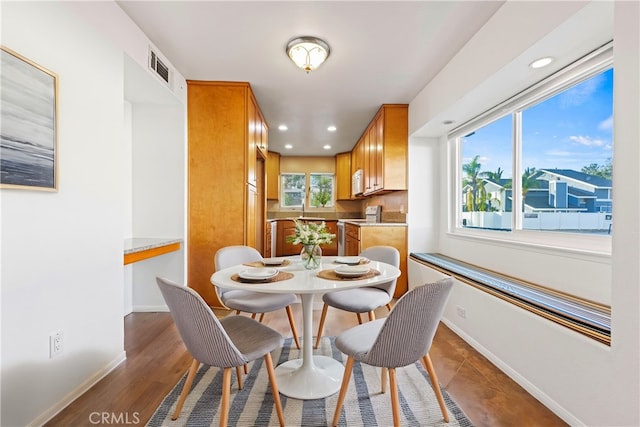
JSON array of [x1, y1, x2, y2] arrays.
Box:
[[409, 2, 640, 426]]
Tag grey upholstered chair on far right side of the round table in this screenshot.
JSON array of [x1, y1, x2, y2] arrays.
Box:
[[315, 246, 400, 348]]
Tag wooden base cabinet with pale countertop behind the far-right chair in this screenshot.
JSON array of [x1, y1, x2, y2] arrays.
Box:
[[344, 223, 408, 298]]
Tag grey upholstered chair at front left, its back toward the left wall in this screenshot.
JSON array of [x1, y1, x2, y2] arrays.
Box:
[[156, 277, 284, 426]]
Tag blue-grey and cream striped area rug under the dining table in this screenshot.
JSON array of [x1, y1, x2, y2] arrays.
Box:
[[147, 337, 472, 427]]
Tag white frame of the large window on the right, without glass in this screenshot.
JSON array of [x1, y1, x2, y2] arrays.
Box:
[[447, 42, 615, 256]]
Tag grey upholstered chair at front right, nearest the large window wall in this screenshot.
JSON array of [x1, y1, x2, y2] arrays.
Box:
[[333, 277, 453, 426]]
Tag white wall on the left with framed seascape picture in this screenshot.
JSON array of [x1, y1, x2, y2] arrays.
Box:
[[0, 2, 185, 426]]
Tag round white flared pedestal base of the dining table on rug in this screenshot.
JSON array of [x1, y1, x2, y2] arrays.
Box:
[[276, 356, 344, 400]]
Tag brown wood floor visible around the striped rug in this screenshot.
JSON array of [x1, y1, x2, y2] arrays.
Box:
[[46, 304, 567, 427]]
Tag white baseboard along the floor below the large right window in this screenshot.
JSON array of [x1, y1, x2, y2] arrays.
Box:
[[442, 317, 585, 426]]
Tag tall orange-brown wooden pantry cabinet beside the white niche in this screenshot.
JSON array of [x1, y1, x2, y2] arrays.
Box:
[[187, 80, 268, 307]]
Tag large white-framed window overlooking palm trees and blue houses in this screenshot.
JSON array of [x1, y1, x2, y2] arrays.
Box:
[[449, 44, 614, 253]]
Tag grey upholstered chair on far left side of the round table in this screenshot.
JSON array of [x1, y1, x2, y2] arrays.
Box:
[[215, 245, 300, 348]]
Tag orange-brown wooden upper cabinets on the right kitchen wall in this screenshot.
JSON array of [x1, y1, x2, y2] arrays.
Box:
[[351, 104, 409, 196]]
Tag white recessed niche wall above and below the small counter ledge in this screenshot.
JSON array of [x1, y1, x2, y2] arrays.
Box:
[[131, 102, 186, 311]]
